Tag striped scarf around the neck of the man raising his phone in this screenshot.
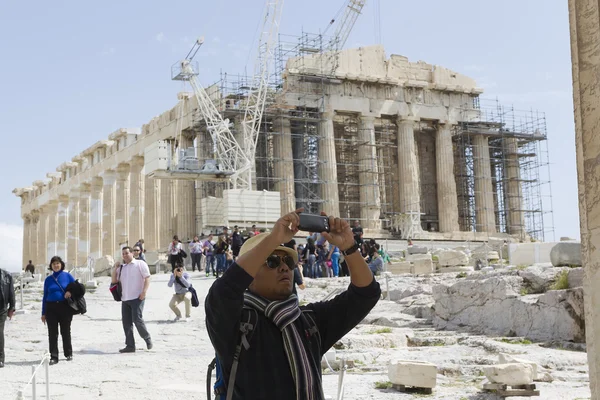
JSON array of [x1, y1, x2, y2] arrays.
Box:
[[244, 291, 324, 400]]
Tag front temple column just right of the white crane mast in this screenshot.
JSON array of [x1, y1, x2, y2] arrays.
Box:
[[273, 116, 296, 214]]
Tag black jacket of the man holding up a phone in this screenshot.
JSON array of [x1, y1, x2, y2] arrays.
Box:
[[205, 263, 381, 400]]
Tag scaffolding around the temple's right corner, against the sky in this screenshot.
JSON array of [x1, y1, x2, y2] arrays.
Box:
[[453, 98, 554, 241]]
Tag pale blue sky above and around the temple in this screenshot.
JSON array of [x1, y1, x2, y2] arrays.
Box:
[[0, 0, 579, 265]]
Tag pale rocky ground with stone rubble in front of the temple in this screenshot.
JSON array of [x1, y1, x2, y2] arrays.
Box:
[[0, 250, 590, 400]]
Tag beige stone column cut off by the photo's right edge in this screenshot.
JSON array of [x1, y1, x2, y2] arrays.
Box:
[[569, 0, 600, 400]]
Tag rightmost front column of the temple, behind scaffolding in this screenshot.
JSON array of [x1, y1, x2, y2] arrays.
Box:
[[504, 138, 525, 238]]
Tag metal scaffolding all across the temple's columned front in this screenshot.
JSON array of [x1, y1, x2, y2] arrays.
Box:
[[197, 33, 554, 240]]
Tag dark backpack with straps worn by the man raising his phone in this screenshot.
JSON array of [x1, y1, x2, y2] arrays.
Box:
[[206, 306, 321, 400]]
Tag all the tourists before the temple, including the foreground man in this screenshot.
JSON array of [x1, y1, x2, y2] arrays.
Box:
[[0, 210, 381, 399]]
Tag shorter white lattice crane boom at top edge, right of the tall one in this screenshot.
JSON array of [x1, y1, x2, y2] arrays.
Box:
[[324, 0, 366, 75]]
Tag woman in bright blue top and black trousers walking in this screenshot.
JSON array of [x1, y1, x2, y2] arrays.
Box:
[[42, 256, 75, 365]]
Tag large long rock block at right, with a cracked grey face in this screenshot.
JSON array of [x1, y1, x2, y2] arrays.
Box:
[[433, 276, 585, 342]]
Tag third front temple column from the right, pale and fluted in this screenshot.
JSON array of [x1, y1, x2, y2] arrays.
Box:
[[435, 123, 460, 232]]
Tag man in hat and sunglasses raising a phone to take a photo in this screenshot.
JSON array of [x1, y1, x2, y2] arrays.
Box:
[[205, 209, 381, 400]]
